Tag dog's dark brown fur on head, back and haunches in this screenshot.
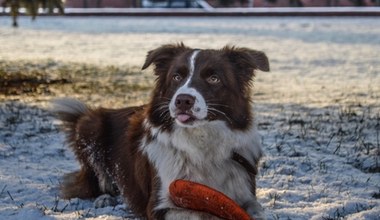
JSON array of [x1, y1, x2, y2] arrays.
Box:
[[56, 44, 269, 219]]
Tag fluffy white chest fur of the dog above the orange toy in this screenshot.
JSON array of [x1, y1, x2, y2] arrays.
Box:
[[141, 118, 261, 209]]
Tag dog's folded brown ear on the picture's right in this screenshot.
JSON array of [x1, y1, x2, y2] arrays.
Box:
[[223, 46, 270, 74]]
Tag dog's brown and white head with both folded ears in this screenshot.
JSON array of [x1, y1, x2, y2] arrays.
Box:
[[142, 44, 269, 130]]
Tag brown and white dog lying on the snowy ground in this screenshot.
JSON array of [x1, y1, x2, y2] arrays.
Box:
[[55, 44, 269, 220]]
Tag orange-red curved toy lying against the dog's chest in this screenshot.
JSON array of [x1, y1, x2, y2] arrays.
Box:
[[169, 180, 252, 220]]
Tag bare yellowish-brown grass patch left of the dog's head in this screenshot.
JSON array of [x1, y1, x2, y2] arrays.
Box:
[[0, 60, 153, 102]]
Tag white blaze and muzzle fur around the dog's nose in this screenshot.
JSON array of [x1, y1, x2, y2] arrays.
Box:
[[169, 50, 207, 124]]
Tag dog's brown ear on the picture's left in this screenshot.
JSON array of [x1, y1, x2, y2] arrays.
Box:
[[142, 43, 190, 75]]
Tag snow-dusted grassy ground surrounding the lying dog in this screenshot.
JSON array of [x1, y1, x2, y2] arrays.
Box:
[[0, 17, 380, 219]]
